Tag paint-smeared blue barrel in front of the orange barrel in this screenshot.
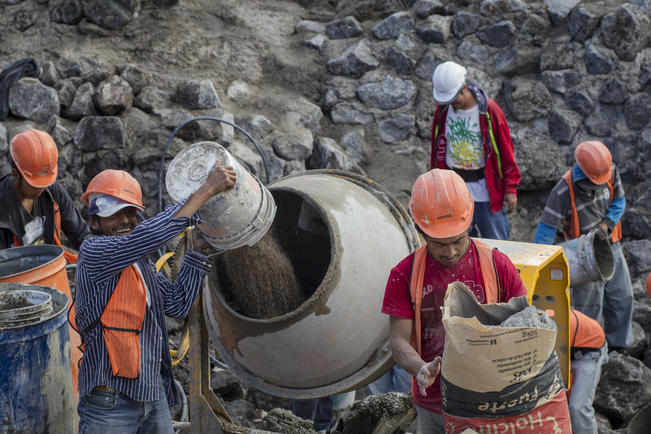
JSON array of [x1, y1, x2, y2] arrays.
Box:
[[0, 283, 76, 433]]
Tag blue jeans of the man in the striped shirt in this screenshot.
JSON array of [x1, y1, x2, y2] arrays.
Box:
[[77, 386, 174, 434]]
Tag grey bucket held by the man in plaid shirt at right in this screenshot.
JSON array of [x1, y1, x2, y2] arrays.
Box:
[[559, 231, 615, 286]]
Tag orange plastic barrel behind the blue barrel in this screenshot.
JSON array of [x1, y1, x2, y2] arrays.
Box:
[[0, 244, 82, 402]]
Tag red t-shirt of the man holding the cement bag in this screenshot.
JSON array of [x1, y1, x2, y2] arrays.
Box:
[[382, 243, 527, 413]]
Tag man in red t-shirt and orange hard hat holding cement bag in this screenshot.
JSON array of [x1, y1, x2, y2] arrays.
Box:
[[382, 169, 527, 433]]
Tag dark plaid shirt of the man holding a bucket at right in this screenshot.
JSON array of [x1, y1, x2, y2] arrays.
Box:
[[536, 165, 624, 242]]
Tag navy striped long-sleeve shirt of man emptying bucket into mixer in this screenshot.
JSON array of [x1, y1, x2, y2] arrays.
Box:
[[75, 203, 210, 405]]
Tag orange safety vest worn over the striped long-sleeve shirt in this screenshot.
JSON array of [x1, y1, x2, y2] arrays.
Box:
[[68, 264, 147, 378]]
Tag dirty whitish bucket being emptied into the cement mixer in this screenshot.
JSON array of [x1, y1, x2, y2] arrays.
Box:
[[165, 141, 276, 250]]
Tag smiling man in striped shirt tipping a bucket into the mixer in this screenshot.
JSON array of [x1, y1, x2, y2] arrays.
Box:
[[71, 165, 236, 434]]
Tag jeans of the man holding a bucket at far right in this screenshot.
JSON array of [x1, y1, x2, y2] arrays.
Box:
[[571, 243, 633, 347]]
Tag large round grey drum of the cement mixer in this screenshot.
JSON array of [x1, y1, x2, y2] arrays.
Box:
[[204, 170, 420, 399]]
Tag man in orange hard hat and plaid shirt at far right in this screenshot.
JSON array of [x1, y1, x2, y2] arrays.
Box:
[[534, 141, 633, 352]]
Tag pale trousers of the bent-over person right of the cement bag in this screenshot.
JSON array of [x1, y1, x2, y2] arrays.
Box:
[[568, 345, 608, 434]]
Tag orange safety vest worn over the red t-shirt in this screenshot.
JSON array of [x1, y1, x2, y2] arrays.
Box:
[[409, 238, 505, 356]]
